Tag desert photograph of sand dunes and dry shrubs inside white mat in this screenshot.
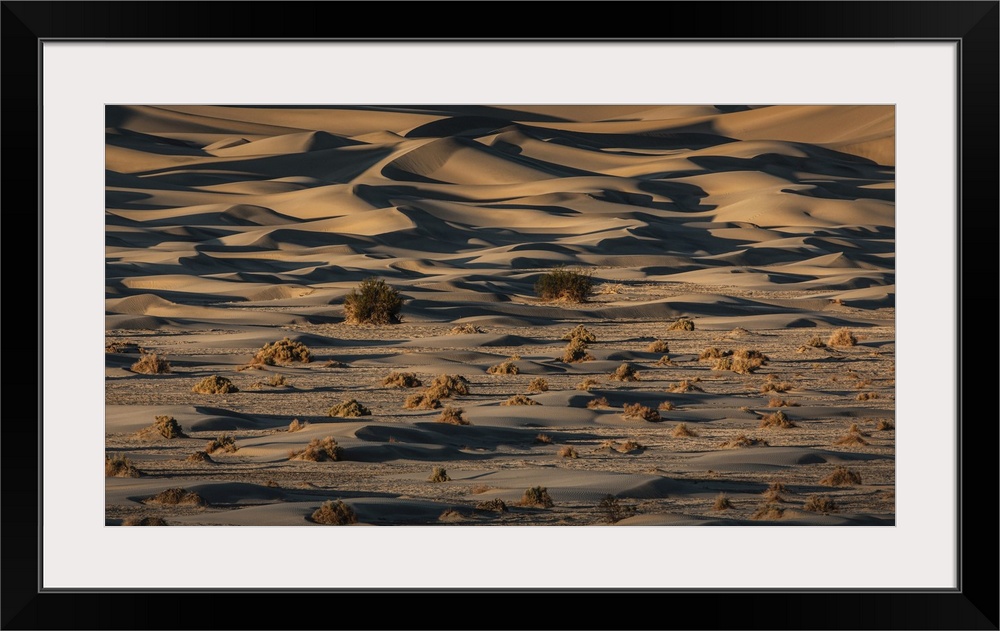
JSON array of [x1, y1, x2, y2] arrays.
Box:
[[105, 105, 896, 527]]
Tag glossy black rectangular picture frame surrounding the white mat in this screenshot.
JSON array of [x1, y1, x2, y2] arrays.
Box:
[[0, 1, 1000, 629]]
